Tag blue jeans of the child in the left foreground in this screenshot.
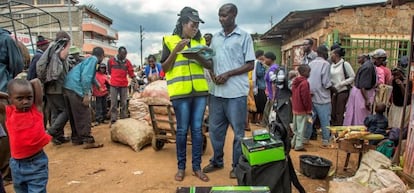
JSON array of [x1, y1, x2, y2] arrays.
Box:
[[10, 151, 49, 193]]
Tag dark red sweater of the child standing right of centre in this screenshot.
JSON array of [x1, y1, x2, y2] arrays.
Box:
[[292, 76, 312, 115]]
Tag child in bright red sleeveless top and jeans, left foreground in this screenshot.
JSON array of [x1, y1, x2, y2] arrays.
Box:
[[0, 79, 52, 193]]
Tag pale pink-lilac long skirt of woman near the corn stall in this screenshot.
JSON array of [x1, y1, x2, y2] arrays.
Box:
[[343, 86, 375, 126]]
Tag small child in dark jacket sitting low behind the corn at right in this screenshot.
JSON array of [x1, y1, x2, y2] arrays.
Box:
[[364, 102, 388, 145]]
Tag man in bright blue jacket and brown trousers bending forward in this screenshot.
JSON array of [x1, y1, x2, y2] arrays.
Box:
[[63, 47, 105, 147]]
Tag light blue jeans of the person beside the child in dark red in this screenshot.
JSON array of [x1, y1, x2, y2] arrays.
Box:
[[304, 103, 331, 145]]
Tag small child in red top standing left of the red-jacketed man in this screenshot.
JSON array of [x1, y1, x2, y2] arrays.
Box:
[[93, 63, 109, 125]]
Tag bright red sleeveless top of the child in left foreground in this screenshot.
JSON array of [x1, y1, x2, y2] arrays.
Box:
[[6, 104, 52, 159]]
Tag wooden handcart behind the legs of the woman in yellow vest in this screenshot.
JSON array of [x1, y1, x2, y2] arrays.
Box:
[[148, 105, 208, 154]]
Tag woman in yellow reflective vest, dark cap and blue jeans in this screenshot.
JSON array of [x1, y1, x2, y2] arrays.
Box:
[[161, 7, 212, 182]]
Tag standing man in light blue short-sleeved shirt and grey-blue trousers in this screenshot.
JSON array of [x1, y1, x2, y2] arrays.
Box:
[[203, 3, 255, 178]]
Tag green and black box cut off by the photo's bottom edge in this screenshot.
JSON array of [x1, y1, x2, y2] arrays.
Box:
[[176, 186, 270, 193]]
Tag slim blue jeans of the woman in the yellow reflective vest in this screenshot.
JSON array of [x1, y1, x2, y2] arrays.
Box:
[[172, 96, 207, 171]]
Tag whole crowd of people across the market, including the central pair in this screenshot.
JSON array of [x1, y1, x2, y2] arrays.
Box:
[[0, 3, 412, 193]]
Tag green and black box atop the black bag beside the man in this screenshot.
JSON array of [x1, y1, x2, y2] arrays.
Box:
[[242, 137, 285, 166]]
